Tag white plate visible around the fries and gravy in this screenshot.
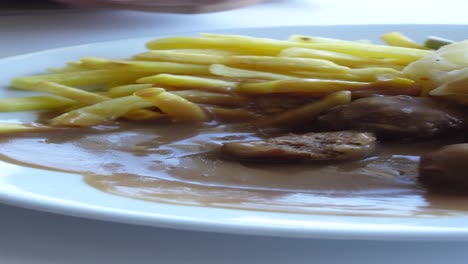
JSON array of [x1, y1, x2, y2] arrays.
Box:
[[0, 25, 468, 240]]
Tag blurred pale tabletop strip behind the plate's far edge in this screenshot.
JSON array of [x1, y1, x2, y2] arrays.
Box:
[[0, 0, 468, 57]]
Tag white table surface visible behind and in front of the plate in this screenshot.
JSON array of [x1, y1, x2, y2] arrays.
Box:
[[0, 0, 468, 264]]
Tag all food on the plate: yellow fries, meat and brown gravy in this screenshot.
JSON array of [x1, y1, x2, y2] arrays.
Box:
[[0, 32, 468, 215]]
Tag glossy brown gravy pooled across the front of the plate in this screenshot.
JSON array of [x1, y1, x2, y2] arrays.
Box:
[[0, 121, 468, 216]]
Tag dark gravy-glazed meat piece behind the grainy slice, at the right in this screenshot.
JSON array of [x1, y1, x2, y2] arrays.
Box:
[[319, 95, 465, 138]]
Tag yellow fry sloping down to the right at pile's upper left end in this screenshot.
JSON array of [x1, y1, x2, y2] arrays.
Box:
[[29, 81, 109, 105]]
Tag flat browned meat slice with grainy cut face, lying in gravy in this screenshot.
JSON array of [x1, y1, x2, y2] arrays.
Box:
[[221, 131, 375, 162]]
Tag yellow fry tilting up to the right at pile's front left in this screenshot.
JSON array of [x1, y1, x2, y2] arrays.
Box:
[[49, 95, 153, 127]]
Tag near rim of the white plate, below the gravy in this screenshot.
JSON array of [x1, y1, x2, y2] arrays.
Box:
[[0, 182, 468, 241]]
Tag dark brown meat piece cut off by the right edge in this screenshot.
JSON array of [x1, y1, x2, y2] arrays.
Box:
[[418, 144, 468, 193]]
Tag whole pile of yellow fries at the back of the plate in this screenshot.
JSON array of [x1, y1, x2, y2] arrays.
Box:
[[0, 32, 433, 133]]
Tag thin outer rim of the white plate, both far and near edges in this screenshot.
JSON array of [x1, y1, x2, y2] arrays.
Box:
[[0, 24, 468, 241]]
